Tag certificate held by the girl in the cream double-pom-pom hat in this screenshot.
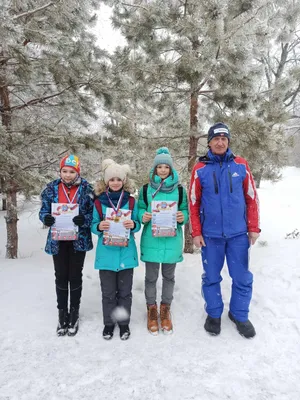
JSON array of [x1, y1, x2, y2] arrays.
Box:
[[103, 207, 131, 247]]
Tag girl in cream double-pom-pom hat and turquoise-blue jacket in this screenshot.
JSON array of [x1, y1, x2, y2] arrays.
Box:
[[92, 160, 140, 340]]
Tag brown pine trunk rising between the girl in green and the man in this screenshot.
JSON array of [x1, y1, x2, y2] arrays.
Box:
[[183, 82, 199, 253]]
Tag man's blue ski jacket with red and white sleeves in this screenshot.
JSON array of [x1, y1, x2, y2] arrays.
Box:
[[190, 149, 260, 238]]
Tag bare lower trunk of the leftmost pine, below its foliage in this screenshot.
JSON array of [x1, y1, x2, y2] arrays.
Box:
[[4, 182, 18, 258]]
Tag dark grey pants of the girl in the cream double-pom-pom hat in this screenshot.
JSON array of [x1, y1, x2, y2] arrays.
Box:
[[99, 268, 133, 325]]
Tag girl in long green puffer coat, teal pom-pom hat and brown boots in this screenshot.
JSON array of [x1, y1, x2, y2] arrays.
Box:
[[139, 147, 189, 335]]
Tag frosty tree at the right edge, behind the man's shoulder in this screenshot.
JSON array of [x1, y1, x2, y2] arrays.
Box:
[[216, 0, 300, 186]]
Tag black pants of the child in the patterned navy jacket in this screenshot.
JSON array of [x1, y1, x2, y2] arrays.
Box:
[[53, 241, 86, 309]]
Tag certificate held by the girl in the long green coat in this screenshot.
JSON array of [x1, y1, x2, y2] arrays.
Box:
[[151, 201, 177, 237]]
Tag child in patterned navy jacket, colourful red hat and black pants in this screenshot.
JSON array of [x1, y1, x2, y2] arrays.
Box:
[[39, 154, 93, 336]]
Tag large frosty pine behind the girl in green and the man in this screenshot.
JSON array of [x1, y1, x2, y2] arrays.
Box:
[[102, 0, 269, 252]]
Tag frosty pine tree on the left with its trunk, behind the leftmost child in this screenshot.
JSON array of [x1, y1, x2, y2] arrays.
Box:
[[0, 0, 110, 258]]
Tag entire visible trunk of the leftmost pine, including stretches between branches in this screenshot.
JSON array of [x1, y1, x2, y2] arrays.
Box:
[[0, 50, 18, 258]]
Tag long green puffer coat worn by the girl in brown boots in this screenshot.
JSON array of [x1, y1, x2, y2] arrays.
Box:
[[138, 178, 189, 264]]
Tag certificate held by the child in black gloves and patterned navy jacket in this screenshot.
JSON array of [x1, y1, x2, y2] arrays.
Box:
[[51, 203, 79, 240]]
